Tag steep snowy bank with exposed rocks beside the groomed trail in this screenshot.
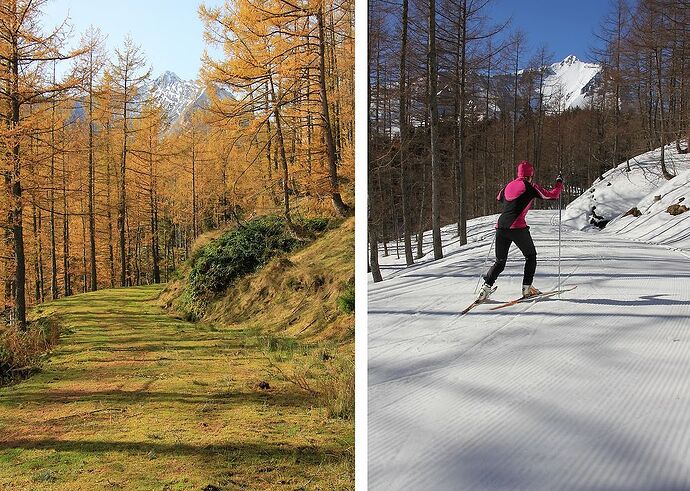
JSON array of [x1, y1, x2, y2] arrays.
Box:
[[563, 145, 690, 249]]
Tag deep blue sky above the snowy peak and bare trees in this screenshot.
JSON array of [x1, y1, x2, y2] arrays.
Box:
[[491, 0, 609, 61]]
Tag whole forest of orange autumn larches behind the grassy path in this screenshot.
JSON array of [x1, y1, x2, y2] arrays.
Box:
[[0, 0, 354, 326]]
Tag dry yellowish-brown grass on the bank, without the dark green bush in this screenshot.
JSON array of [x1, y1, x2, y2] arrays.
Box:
[[163, 219, 355, 344]]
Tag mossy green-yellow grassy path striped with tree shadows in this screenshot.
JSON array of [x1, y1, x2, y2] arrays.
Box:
[[0, 287, 354, 490]]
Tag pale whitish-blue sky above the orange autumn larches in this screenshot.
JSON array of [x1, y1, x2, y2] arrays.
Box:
[[44, 0, 222, 79]]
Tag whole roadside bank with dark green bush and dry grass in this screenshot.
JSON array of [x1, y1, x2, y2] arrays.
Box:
[[161, 217, 354, 343]]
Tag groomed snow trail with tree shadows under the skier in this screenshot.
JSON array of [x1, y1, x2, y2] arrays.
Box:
[[368, 211, 690, 491]]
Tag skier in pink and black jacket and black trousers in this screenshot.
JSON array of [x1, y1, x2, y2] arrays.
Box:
[[477, 160, 563, 302]]
